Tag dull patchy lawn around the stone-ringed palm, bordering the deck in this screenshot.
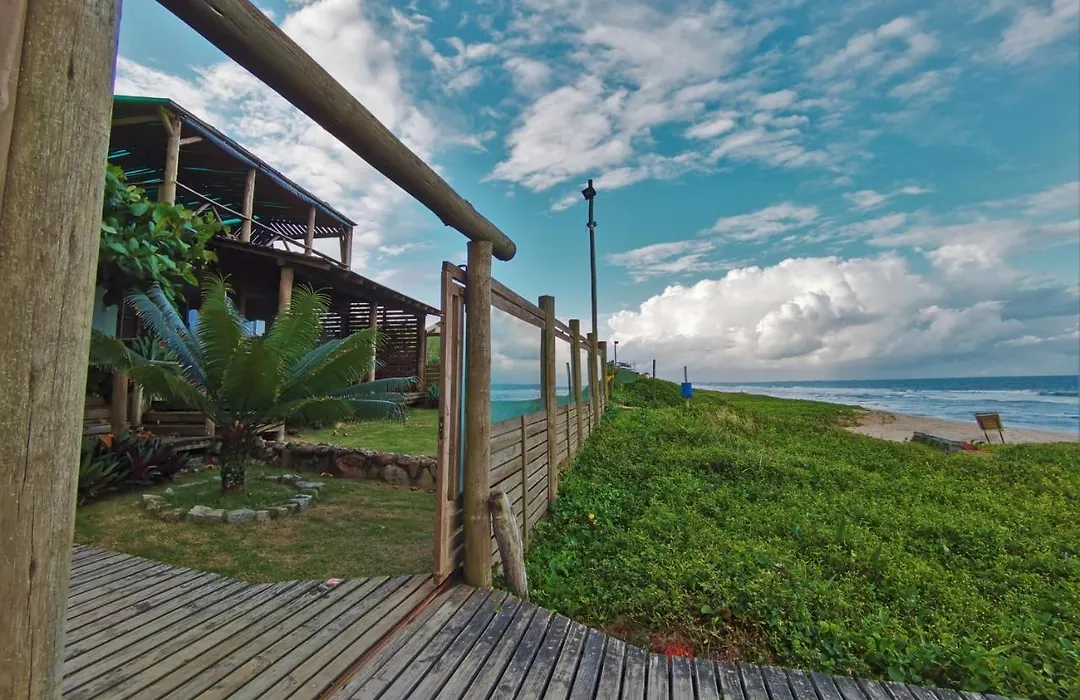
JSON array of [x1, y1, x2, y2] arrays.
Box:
[[75, 468, 435, 582]]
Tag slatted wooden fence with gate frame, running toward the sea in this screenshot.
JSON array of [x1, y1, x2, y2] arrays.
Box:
[[435, 263, 607, 580]]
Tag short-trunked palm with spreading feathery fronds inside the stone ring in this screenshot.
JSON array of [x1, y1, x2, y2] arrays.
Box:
[[91, 278, 416, 490]]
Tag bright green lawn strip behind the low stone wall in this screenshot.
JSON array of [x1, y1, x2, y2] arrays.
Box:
[[298, 408, 438, 457]]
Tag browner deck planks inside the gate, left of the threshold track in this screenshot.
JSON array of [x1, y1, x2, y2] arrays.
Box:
[[64, 547, 435, 700]]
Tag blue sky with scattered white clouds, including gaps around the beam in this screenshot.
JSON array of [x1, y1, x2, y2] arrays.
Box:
[[117, 0, 1080, 381]]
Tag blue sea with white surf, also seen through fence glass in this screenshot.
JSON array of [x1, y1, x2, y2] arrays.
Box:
[[491, 376, 1080, 433]]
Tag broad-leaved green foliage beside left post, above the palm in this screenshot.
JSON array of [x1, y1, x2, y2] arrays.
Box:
[[97, 165, 225, 305]]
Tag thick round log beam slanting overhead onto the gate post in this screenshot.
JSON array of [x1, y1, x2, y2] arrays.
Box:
[[158, 0, 517, 260]]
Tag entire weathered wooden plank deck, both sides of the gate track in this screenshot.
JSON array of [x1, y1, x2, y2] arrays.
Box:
[[64, 547, 1003, 700]]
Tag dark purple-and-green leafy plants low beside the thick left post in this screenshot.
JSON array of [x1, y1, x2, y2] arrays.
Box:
[[78, 435, 184, 504]]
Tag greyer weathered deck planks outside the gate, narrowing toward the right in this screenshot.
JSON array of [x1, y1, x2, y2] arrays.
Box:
[[332, 585, 1019, 700]]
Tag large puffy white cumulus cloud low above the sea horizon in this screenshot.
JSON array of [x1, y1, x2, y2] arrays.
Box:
[[608, 254, 1076, 380]]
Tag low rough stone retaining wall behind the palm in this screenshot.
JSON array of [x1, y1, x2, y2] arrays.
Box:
[[266, 443, 437, 489]]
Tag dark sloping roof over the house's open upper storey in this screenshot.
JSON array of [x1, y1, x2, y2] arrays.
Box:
[[109, 95, 355, 245]]
